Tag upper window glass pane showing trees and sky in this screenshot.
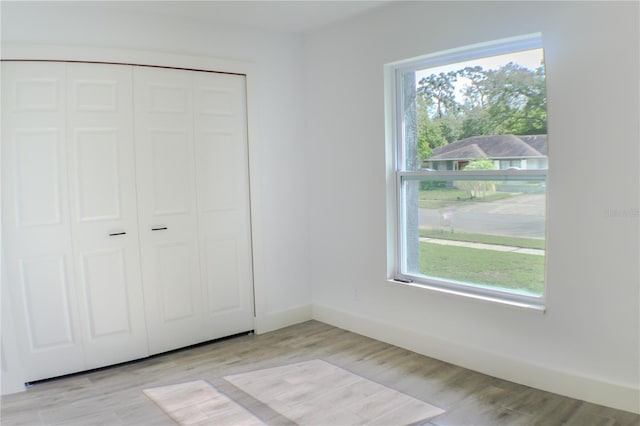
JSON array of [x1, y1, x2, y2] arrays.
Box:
[[397, 48, 547, 171]]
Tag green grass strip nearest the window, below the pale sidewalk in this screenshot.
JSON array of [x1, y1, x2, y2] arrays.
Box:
[[419, 242, 544, 295]]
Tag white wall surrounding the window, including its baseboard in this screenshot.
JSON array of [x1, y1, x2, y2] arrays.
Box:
[[305, 2, 640, 412]]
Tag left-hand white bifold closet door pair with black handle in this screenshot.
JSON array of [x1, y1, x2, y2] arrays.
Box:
[[2, 62, 147, 381]]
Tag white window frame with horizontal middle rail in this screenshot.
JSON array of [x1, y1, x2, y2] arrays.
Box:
[[384, 33, 547, 312]]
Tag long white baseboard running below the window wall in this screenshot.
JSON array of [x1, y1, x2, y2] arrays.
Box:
[[312, 304, 640, 414]]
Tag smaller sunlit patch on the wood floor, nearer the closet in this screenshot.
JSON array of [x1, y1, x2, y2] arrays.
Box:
[[144, 380, 264, 426]]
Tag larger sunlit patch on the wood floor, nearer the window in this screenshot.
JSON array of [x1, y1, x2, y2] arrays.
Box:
[[225, 359, 444, 426]]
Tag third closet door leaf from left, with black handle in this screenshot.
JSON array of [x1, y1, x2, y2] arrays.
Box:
[[134, 67, 207, 353]]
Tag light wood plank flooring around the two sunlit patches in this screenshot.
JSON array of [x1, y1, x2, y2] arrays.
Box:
[[0, 321, 640, 426]]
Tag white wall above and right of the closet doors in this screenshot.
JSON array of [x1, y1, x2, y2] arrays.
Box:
[[1, 2, 311, 332]]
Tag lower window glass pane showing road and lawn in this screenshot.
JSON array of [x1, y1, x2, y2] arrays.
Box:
[[403, 176, 546, 295]]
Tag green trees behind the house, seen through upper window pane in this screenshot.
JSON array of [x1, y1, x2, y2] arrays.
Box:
[[416, 62, 547, 160]]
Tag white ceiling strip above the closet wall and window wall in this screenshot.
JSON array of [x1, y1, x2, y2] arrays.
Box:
[[97, 0, 393, 33]]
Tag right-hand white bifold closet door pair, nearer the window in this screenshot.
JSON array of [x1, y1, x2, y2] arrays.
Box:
[[134, 67, 253, 354]]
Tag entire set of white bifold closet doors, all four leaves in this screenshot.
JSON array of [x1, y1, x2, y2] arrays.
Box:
[[2, 62, 253, 382]]
